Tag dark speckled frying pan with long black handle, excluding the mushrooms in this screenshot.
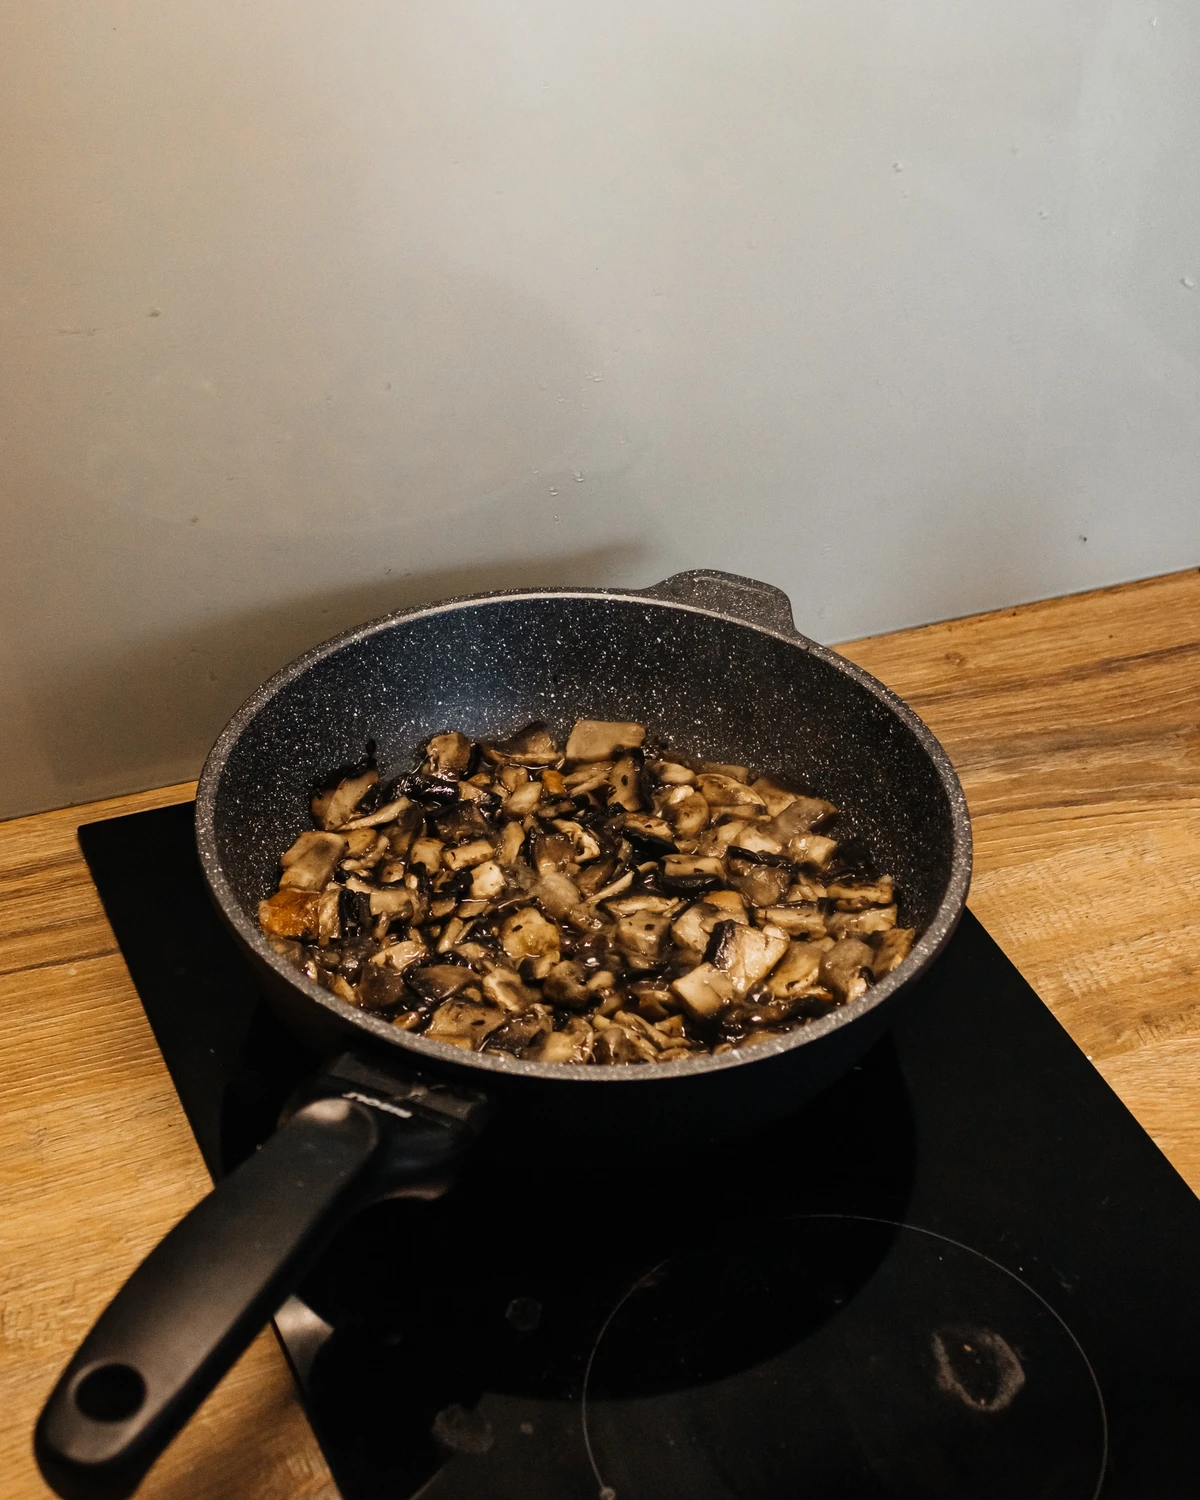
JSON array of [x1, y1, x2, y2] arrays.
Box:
[[35, 572, 971, 1500]]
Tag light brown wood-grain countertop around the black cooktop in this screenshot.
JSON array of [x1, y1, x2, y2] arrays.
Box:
[[0, 570, 1200, 1500]]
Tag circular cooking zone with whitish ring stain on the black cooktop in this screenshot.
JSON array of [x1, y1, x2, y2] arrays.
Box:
[[581, 1214, 1109, 1500]]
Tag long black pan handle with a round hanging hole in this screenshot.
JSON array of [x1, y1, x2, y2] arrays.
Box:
[[33, 1080, 482, 1500]]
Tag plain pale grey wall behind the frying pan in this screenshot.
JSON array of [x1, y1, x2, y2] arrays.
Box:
[[0, 0, 1200, 813]]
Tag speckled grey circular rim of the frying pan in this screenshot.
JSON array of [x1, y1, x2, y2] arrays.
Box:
[[195, 587, 972, 1088]]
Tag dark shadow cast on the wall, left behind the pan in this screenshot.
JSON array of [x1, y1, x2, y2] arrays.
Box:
[[33, 545, 639, 801]]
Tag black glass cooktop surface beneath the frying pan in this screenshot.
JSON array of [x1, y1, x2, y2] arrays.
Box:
[[80, 806, 1200, 1500]]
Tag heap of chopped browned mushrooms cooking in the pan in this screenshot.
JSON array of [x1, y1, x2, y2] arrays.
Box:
[[260, 720, 900, 1067]]
